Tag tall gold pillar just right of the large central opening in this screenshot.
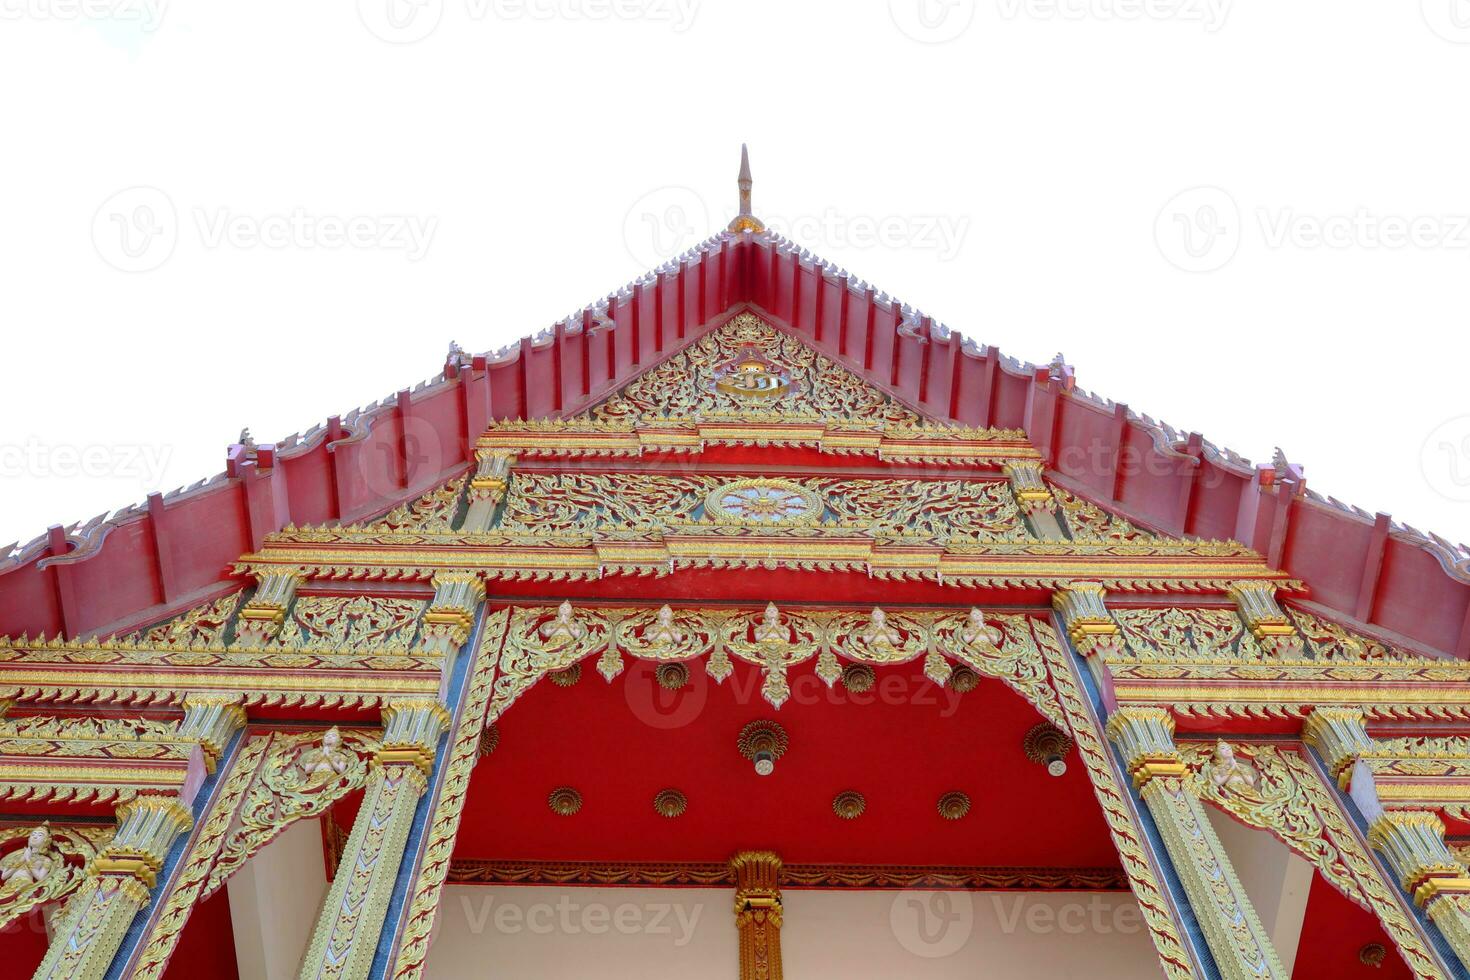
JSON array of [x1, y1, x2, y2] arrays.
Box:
[[1107, 708, 1291, 980]]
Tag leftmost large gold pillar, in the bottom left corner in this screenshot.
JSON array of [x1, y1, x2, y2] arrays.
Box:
[[35, 796, 193, 980]]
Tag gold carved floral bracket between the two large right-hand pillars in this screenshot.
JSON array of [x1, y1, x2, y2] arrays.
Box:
[[1179, 742, 1446, 980]]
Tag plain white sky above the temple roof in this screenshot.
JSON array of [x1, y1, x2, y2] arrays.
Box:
[[0, 0, 1470, 544]]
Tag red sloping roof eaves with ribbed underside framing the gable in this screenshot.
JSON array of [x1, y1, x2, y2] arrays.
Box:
[[0, 218, 1470, 658]]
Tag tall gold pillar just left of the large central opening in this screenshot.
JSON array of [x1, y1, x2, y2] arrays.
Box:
[[298, 701, 450, 980]]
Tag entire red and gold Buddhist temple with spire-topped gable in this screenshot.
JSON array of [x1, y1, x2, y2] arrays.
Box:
[[0, 147, 1470, 980]]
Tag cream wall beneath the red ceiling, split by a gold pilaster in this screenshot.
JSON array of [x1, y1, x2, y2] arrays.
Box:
[[428, 886, 1160, 980]]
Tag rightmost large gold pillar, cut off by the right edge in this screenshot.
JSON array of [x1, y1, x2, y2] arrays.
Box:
[[1369, 810, 1470, 967]]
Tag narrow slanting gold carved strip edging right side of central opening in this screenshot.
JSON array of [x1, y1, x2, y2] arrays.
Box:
[[1033, 623, 1198, 980]]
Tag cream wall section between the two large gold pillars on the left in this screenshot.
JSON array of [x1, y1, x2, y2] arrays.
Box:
[[225, 820, 326, 980]]
